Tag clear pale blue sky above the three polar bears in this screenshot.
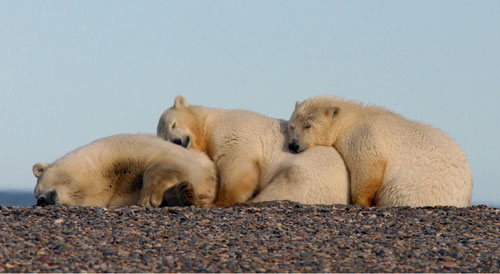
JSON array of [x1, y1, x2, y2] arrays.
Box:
[[0, 0, 500, 204]]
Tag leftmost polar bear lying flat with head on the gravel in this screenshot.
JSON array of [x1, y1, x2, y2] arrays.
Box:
[[33, 134, 217, 207]]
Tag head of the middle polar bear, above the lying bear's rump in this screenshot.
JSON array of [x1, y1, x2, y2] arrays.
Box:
[[157, 96, 201, 150]]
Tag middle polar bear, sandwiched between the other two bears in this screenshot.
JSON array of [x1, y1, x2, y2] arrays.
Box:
[[157, 96, 350, 206]]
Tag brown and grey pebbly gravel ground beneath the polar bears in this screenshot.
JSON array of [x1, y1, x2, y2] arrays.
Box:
[[0, 202, 500, 272]]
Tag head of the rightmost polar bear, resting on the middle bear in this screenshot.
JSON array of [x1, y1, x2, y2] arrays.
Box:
[[287, 96, 345, 153]]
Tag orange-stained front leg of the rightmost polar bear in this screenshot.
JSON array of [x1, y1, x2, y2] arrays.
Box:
[[351, 160, 387, 207]]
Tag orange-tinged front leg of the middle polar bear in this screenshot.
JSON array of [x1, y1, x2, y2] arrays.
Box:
[[215, 159, 260, 206]]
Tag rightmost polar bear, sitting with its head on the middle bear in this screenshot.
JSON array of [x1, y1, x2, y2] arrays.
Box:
[[287, 95, 473, 207]]
